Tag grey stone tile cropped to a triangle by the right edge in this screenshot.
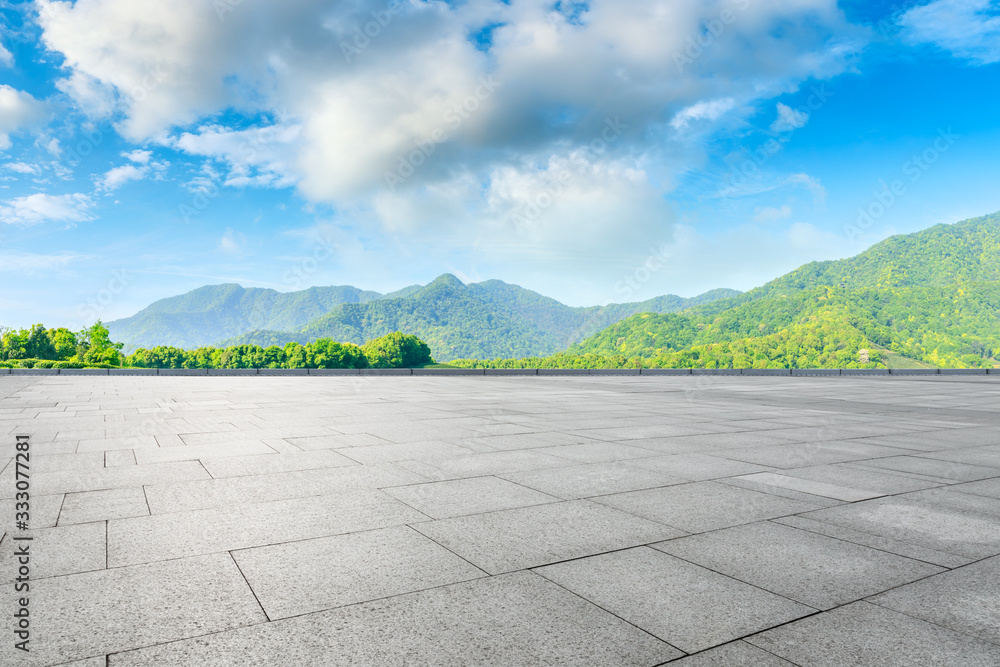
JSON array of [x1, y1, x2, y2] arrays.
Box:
[[868, 557, 1000, 644]]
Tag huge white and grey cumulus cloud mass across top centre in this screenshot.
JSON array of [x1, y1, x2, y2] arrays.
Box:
[[40, 0, 861, 256]]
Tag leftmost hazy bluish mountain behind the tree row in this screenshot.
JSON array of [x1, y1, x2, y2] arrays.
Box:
[[106, 284, 382, 349]]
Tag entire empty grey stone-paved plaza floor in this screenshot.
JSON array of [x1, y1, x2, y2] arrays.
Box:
[[0, 376, 1000, 667]]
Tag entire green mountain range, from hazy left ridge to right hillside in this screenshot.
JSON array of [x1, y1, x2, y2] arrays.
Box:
[[108, 213, 1000, 368]]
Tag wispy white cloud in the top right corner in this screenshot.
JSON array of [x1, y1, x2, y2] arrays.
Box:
[[899, 0, 1000, 65]]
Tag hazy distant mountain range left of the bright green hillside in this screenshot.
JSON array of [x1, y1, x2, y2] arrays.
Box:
[[107, 274, 739, 361]]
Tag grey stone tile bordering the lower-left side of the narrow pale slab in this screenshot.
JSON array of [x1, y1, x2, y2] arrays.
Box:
[[595, 482, 818, 533]]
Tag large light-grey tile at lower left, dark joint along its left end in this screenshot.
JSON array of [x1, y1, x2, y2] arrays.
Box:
[[233, 526, 486, 620]]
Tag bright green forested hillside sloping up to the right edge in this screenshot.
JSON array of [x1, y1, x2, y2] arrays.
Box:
[[568, 214, 1000, 368]]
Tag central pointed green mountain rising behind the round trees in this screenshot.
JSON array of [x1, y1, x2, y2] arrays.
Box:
[[218, 274, 739, 361]]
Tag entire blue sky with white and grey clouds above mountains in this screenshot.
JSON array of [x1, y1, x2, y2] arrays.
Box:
[[0, 0, 1000, 329]]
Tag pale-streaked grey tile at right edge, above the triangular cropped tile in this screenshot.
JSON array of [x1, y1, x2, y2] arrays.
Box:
[[805, 489, 1000, 559]]
